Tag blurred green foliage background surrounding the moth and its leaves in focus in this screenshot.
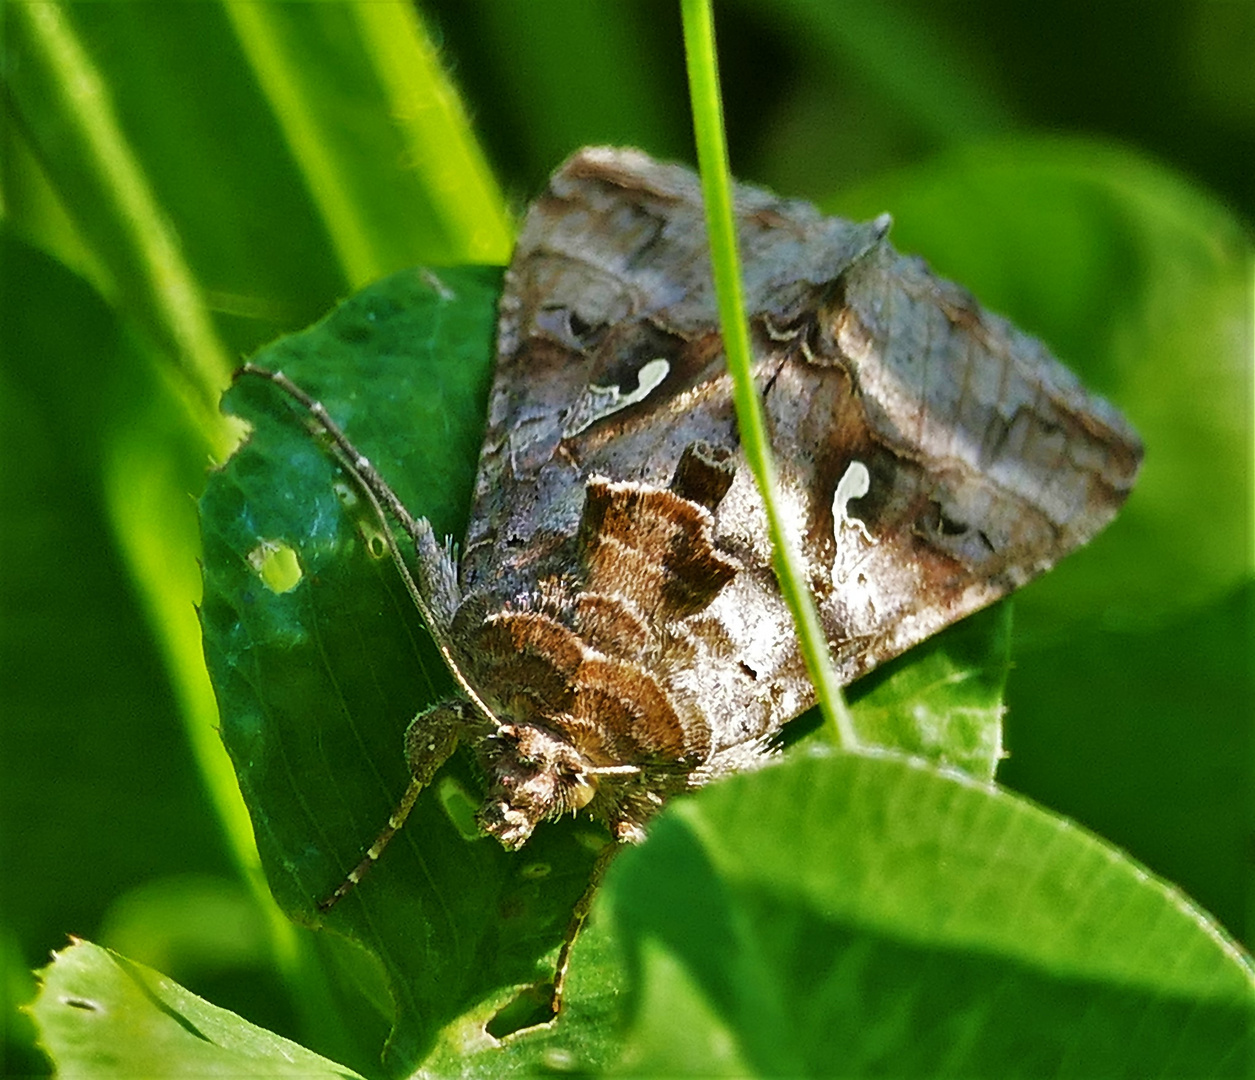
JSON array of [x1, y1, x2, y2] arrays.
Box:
[[0, 0, 1255, 1072]]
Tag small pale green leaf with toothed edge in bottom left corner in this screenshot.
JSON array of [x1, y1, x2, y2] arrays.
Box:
[[29, 941, 358, 1080]]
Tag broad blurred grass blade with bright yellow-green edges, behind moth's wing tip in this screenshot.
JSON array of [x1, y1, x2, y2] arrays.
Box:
[[225, 3, 512, 287]]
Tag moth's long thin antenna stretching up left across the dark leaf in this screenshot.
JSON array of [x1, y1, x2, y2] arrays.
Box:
[[236, 363, 497, 732]]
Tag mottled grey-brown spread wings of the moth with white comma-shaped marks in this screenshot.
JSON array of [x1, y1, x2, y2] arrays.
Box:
[[462, 149, 1141, 832]]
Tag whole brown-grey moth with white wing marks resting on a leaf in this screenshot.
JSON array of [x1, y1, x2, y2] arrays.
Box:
[[243, 148, 1142, 906]]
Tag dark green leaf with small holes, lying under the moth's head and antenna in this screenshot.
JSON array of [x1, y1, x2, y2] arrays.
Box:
[[201, 268, 604, 1067]]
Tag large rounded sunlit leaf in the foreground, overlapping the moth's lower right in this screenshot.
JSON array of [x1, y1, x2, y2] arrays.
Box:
[[459, 756, 1255, 1077]]
